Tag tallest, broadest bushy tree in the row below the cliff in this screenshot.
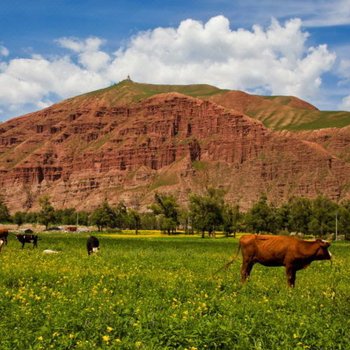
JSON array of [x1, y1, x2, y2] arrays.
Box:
[[190, 188, 224, 238]]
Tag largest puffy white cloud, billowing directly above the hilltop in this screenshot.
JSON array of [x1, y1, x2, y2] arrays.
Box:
[[110, 16, 335, 98]]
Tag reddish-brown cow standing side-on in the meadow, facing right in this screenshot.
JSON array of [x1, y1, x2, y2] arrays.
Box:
[[220, 235, 331, 287]]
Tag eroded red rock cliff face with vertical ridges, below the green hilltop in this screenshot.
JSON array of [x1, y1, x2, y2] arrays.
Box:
[[0, 93, 350, 211]]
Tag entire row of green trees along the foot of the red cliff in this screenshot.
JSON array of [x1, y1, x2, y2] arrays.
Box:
[[0, 188, 350, 239]]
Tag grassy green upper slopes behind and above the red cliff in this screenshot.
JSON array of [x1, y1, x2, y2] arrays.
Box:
[[71, 79, 350, 131]]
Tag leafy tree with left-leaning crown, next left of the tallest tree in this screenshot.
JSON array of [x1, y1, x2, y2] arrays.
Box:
[[151, 193, 179, 234]]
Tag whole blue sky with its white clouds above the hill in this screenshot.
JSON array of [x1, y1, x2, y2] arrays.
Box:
[[0, 0, 350, 120]]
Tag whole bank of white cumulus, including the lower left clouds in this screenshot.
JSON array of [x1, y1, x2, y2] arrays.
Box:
[[0, 16, 335, 117]]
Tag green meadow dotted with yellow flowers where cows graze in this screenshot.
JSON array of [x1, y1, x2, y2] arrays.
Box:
[[0, 233, 350, 350]]
